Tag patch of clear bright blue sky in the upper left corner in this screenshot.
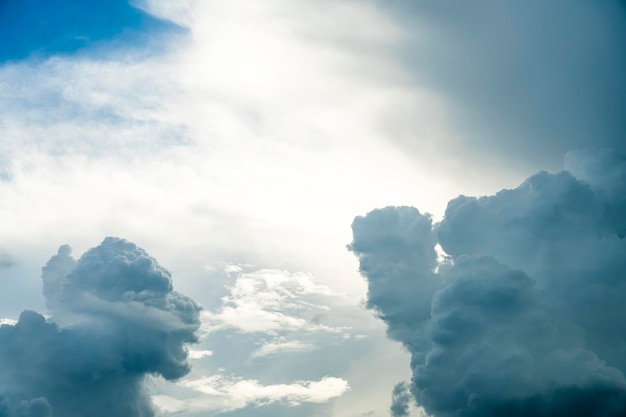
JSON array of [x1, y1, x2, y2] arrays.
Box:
[[0, 0, 180, 63]]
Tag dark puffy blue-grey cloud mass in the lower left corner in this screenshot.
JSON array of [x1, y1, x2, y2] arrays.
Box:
[[0, 238, 200, 417]]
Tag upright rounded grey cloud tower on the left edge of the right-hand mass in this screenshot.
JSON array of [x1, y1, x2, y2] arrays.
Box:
[[348, 207, 437, 339]]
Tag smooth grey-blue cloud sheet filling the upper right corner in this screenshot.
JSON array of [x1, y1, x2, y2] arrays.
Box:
[[381, 0, 626, 169]]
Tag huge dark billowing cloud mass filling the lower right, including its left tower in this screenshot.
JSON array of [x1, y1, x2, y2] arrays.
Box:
[[350, 151, 626, 417]]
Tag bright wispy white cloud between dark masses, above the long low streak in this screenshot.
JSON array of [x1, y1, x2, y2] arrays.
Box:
[[202, 269, 338, 335]]
